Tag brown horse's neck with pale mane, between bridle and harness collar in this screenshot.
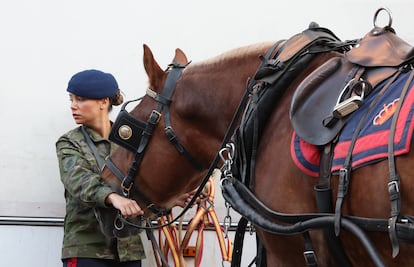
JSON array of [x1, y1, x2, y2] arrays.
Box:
[[174, 43, 272, 162]]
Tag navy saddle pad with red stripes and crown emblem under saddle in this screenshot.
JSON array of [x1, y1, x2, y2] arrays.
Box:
[[291, 70, 414, 176]]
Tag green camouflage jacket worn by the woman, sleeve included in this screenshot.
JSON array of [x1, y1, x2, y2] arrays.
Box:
[[56, 126, 145, 261]]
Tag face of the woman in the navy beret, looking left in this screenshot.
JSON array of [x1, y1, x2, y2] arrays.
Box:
[[69, 94, 105, 126]]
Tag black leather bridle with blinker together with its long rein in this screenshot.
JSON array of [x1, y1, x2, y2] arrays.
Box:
[[106, 55, 255, 230]]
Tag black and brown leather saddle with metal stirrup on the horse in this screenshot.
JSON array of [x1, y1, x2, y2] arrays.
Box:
[[290, 27, 414, 145]]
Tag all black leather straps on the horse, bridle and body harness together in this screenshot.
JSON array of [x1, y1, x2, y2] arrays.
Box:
[[102, 7, 414, 266]]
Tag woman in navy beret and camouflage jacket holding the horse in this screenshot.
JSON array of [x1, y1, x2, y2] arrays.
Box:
[[56, 70, 145, 267]]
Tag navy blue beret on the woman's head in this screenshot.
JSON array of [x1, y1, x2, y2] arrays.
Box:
[[67, 70, 119, 99]]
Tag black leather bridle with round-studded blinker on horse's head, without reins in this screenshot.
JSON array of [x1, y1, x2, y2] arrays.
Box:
[[106, 63, 205, 221]]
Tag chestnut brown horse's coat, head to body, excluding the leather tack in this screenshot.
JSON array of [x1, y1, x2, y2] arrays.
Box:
[[102, 25, 414, 267]]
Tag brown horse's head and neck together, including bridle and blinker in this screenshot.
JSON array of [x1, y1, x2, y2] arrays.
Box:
[[98, 43, 271, 237]]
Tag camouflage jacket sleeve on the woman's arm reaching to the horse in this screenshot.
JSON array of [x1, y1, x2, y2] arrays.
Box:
[[56, 137, 114, 207]]
